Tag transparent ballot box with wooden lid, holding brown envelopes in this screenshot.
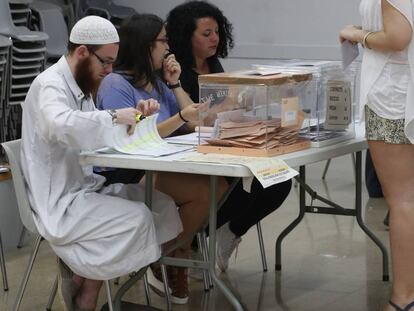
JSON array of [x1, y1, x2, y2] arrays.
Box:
[[198, 70, 314, 156]]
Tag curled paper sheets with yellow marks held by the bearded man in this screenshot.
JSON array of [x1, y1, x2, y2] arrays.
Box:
[[112, 114, 192, 157]]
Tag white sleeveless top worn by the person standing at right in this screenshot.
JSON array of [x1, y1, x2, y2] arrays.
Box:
[[360, 0, 414, 142]]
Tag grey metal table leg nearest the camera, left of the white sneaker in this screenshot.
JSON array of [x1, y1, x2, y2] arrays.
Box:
[[209, 176, 243, 310]]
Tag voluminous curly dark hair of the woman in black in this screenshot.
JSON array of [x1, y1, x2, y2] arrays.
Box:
[[166, 1, 234, 68]]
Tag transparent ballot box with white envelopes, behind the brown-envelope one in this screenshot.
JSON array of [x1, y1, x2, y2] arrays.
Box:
[[253, 60, 358, 147]]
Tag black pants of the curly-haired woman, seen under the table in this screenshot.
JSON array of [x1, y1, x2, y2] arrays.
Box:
[[207, 178, 292, 236]]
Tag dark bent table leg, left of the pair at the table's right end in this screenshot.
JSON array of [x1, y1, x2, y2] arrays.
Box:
[[275, 165, 306, 271]]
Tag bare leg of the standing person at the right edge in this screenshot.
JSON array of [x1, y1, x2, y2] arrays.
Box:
[[369, 141, 414, 310]]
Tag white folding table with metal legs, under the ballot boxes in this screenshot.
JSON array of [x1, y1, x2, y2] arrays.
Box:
[[80, 134, 388, 310]]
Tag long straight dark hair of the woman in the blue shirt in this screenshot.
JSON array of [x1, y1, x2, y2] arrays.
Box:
[[115, 14, 164, 92]]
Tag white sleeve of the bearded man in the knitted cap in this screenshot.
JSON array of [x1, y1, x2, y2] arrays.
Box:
[[39, 83, 113, 150]]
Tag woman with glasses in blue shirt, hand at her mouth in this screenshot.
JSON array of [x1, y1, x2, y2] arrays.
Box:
[[97, 14, 227, 304]]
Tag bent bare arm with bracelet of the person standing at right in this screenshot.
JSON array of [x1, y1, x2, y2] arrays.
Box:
[[339, 0, 412, 52]]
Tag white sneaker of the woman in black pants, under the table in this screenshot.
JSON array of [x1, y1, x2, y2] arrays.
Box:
[[217, 223, 242, 272]]
